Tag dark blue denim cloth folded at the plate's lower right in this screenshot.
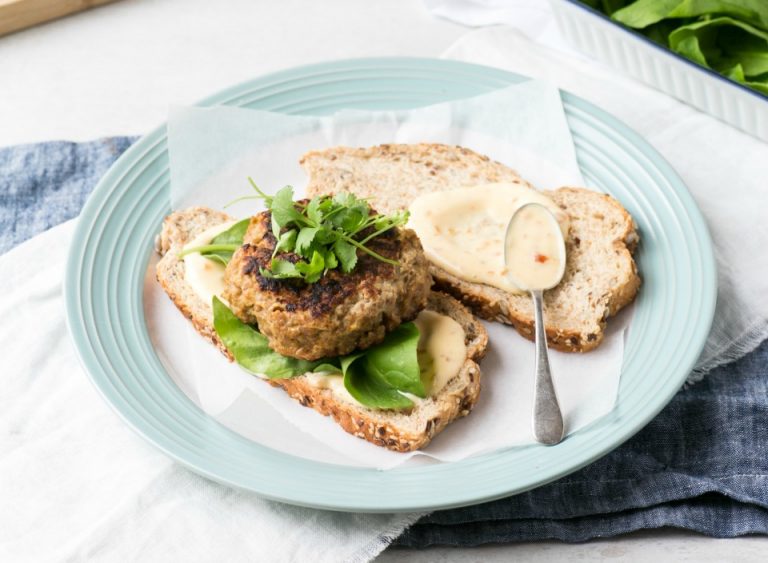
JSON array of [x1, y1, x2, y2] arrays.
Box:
[[395, 340, 768, 547]]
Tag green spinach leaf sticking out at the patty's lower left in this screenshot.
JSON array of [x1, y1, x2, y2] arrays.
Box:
[[212, 297, 318, 379]]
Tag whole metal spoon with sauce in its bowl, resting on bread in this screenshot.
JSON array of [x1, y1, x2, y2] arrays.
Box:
[[504, 203, 565, 446]]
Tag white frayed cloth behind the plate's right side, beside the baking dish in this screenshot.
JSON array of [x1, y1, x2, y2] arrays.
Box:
[[426, 0, 768, 382]]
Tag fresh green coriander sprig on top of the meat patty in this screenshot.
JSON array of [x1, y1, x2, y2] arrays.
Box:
[[240, 178, 408, 283]]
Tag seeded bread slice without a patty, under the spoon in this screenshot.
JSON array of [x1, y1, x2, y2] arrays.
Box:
[[301, 144, 640, 352]]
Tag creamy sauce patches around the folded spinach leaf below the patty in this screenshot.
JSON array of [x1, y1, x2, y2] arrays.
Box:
[[305, 311, 467, 404]]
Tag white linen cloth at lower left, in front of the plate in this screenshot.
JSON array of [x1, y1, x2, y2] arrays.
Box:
[[0, 221, 418, 563]]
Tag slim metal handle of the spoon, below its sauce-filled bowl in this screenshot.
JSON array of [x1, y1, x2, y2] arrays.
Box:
[[531, 290, 563, 446]]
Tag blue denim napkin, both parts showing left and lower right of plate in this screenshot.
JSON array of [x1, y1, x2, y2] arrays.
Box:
[[0, 137, 768, 547]]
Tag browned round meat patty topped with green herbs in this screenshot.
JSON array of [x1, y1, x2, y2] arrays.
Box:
[[224, 211, 432, 360]]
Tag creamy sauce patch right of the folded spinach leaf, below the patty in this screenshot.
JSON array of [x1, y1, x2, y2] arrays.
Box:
[[414, 311, 467, 397]]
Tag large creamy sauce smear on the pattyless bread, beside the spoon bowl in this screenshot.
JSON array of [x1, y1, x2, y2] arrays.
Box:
[[408, 183, 570, 293]]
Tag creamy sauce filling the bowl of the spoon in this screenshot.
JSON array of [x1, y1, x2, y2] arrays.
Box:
[[505, 205, 565, 290]]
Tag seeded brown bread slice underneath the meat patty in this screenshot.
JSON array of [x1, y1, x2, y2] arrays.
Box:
[[156, 207, 488, 452]]
